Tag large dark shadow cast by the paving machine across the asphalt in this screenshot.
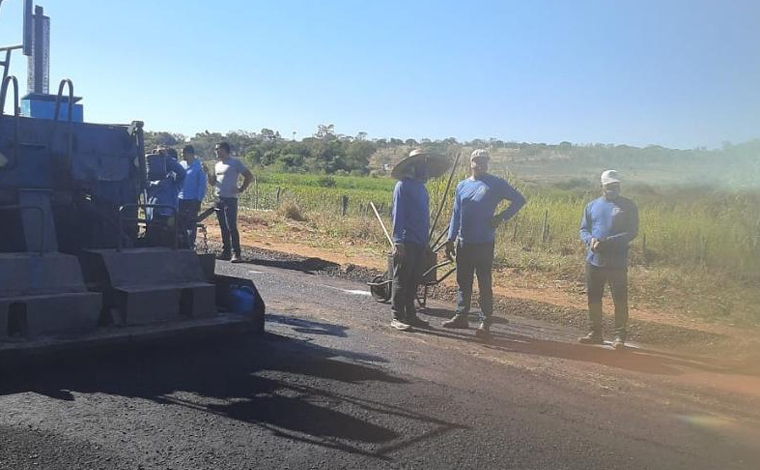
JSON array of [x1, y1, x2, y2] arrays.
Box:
[[0, 317, 464, 460]]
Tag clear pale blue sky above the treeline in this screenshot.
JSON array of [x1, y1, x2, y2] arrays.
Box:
[[0, 0, 760, 148]]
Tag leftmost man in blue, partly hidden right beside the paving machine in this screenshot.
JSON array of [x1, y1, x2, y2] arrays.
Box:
[[145, 148, 185, 246]]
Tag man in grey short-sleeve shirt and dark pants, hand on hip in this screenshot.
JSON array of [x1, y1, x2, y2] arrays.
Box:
[[209, 142, 253, 263]]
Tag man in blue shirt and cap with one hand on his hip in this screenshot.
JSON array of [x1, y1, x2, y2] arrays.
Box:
[[443, 149, 525, 338]]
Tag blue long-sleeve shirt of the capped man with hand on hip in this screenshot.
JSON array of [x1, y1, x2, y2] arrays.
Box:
[[449, 174, 525, 243]]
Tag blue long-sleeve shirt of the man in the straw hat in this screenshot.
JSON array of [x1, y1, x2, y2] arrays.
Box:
[[392, 178, 430, 246]]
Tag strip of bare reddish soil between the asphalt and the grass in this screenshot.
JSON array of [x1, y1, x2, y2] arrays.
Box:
[[200, 213, 760, 360]]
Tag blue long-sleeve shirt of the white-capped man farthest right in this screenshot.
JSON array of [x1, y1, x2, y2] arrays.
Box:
[[580, 197, 639, 268]]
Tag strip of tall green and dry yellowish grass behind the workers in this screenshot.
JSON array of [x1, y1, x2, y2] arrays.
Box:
[[230, 168, 760, 323]]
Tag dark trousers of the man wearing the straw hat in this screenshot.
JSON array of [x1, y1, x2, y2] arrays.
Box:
[[391, 243, 427, 322]]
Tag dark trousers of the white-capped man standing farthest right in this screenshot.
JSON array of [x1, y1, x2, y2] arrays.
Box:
[[586, 263, 628, 339]]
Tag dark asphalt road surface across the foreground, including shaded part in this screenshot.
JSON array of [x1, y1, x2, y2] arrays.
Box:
[[0, 263, 760, 469]]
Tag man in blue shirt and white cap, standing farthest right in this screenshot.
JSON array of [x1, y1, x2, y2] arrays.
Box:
[[580, 170, 639, 349]]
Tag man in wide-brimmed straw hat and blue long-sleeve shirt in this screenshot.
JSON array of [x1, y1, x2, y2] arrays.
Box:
[[391, 150, 430, 331]]
